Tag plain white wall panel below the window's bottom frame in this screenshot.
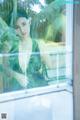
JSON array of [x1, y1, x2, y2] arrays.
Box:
[[0, 91, 73, 120]]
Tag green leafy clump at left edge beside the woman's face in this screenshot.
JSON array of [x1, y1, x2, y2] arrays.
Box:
[[0, 19, 18, 52]]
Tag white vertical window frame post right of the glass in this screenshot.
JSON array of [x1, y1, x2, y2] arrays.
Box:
[[66, 4, 73, 79]]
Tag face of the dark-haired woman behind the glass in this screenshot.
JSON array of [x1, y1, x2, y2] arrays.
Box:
[[15, 17, 30, 39]]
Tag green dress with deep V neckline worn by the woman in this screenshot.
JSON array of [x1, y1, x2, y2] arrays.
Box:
[[5, 40, 48, 91]]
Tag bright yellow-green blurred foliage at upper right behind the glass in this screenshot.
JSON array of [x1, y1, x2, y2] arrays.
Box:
[[45, 14, 65, 42]]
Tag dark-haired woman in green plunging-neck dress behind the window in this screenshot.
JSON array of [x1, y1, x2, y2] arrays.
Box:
[[6, 11, 52, 90]]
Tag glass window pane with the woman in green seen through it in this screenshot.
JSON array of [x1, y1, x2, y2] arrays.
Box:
[[0, 0, 71, 93]]
